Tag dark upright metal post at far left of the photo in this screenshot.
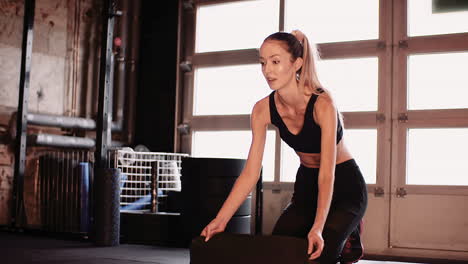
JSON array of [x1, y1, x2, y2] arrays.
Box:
[[11, 0, 36, 227]]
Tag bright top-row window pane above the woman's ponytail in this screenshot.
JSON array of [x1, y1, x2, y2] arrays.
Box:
[[285, 0, 379, 43]]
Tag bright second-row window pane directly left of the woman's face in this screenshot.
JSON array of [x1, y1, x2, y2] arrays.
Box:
[[193, 64, 271, 115]]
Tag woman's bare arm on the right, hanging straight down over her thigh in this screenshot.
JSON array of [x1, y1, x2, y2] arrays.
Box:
[[308, 94, 338, 259]]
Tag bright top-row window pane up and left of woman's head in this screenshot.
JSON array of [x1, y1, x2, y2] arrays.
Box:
[[195, 0, 279, 53]]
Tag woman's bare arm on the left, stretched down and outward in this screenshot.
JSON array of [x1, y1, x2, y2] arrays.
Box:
[[201, 100, 270, 241]]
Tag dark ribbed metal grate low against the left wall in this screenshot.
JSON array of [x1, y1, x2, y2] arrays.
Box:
[[38, 150, 94, 233]]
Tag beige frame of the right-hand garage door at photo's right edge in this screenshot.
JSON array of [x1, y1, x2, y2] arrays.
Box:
[[389, 0, 468, 259]]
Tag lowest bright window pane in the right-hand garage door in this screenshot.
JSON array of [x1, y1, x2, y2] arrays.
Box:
[[406, 128, 468, 186]]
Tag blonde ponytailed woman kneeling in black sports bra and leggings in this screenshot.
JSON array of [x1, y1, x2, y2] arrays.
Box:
[[201, 30, 367, 263]]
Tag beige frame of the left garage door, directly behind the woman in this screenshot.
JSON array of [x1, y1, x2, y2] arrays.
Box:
[[175, 0, 392, 192]]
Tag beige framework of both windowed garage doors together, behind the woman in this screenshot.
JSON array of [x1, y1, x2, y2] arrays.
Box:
[[178, 0, 468, 258]]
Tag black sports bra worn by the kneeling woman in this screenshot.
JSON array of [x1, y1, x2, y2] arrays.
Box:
[[269, 91, 343, 153]]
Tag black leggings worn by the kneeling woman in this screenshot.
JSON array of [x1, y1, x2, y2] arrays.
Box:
[[273, 159, 367, 264]]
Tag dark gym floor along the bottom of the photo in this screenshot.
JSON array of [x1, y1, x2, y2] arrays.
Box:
[[0, 231, 422, 264]]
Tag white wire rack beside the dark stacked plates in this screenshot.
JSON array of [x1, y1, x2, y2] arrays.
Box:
[[113, 147, 188, 213]]
